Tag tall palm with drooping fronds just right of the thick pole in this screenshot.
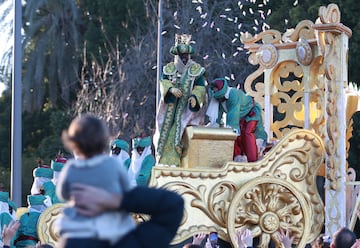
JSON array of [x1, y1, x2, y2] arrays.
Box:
[[23, 0, 81, 112]]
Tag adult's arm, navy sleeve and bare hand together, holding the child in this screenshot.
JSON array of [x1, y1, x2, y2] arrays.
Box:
[[71, 184, 184, 248]]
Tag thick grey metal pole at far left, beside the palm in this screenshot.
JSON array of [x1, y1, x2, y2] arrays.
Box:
[[11, 0, 22, 206]]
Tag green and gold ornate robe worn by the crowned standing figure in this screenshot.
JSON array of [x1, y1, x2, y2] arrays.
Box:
[[156, 60, 206, 166]]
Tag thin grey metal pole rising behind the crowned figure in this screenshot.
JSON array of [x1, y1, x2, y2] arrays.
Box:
[[156, 0, 163, 113]]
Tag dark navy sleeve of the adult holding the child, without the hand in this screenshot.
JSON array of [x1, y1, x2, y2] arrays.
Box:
[[113, 186, 184, 248]]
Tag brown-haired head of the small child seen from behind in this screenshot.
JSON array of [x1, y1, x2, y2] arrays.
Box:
[[62, 114, 109, 158]]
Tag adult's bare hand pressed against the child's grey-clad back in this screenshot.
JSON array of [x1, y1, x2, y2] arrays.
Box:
[[70, 183, 122, 216]]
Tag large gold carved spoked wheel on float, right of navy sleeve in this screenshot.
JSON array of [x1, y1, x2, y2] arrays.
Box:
[[228, 177, 312, 247]]
